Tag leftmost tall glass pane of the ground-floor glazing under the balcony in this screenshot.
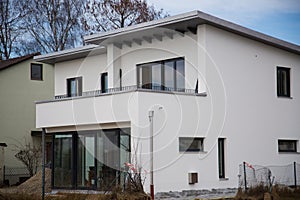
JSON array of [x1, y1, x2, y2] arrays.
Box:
[[53, 135, 72, 187]]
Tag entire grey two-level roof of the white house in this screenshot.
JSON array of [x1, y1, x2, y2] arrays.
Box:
[[34, 11, 300, 64]]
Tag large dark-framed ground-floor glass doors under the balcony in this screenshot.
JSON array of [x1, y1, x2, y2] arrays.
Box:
[[52, 128, 130, 191]]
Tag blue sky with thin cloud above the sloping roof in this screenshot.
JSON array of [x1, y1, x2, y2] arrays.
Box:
[[148, 0, 300, 45]]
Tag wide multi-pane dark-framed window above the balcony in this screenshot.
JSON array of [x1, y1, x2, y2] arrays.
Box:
[[137, 58, 185, 91]]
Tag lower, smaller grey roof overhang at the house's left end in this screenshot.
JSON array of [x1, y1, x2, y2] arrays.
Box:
[[34, 44, 106, 64]]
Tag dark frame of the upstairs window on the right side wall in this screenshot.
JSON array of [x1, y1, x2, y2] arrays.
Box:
[[276, 66, 291, 97]]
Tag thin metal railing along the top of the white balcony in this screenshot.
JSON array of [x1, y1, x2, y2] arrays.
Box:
[[55, 85, 201, 100]]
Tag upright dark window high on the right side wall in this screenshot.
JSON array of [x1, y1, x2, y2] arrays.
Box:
[[277, 67, 291, 97]]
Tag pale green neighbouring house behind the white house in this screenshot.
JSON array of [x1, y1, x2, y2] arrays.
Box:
[[0, 54, 54, 184]]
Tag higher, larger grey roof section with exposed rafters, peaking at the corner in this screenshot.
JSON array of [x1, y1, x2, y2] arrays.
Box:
[[84, 11, 300, 54]]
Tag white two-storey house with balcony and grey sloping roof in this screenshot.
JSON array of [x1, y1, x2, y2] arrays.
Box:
[[35, 11, 300, 192]]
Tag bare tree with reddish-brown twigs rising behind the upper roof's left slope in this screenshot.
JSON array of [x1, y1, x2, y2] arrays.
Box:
[[83, 0, 168, 33]]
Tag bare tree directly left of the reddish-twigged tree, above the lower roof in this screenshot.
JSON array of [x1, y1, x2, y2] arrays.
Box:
[[25, 0, 83, 53]]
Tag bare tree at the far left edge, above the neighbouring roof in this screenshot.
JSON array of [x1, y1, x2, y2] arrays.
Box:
[[0, 0, 27, 59]]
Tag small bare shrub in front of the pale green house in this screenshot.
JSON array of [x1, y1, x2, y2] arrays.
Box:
[[15, 143, 42, 176]]
